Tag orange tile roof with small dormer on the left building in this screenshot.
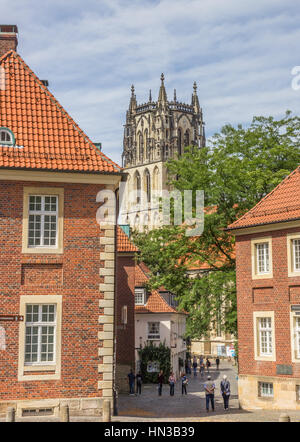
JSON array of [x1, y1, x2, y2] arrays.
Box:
[[0, 51, 121, 173]]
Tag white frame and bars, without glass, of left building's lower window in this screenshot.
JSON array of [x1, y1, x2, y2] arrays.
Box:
[[24, 303, 57, 366]]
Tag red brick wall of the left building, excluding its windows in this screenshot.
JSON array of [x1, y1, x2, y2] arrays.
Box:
[[0, 181, 107, 401]]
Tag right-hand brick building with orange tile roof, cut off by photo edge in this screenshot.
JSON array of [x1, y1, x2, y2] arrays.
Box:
[[228, 167, 300, 409]]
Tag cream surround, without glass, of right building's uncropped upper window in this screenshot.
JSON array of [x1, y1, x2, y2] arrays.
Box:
[[251, 237, 273, 279]]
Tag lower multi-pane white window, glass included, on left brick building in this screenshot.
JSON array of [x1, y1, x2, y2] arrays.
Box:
[[24, 304, 56, 365]]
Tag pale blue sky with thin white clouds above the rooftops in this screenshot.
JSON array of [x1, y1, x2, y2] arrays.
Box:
[[0, 0, 300, 164]]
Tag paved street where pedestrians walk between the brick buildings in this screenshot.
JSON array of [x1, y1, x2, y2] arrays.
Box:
[[0, 362, 300, 422]]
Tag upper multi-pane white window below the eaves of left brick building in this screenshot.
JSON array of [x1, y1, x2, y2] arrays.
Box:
[[28, 195, 58, 247]]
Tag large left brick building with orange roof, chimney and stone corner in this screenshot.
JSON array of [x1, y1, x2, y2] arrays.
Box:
[[0, 26, 121, 416]]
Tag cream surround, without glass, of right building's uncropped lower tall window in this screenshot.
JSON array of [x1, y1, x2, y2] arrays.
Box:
[[253, 311, 276, 362]]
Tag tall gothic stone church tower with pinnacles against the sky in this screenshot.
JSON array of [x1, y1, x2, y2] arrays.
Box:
[[121, 74, 205, 228]]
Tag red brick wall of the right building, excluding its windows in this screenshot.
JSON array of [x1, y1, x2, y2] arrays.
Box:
[[236, 228, 300, 378]]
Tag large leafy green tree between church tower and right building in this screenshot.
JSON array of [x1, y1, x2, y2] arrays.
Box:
[[134, 111, 300, 338]]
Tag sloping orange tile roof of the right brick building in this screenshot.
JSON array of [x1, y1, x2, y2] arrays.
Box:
[[227, 166, 300, 230]]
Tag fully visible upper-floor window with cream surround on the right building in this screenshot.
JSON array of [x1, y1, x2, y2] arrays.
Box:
[[251, 237, 273, 279]]
